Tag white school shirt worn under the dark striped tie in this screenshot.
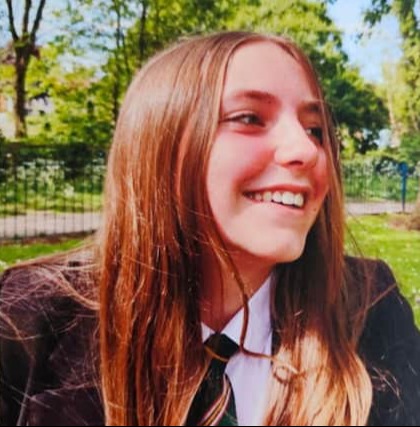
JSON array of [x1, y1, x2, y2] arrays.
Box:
[[202, 275, 273, 426]]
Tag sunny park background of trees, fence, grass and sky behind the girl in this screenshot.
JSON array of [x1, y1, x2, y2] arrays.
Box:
[[0, 0, 420, 325]]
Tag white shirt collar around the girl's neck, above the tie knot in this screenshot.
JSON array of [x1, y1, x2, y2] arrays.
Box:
[[201, 274, 274, 353]]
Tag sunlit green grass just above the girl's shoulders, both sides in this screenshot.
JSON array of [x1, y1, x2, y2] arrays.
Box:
[[0, 215, 420, 326]]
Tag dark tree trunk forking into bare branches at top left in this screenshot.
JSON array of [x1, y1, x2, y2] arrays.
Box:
[[6, 0, 46, 138]]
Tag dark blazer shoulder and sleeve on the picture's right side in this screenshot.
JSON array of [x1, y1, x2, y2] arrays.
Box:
[[346, 258, 420, 426]]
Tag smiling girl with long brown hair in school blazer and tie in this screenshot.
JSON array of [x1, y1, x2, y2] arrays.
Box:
[[0, 32, 420, 425]]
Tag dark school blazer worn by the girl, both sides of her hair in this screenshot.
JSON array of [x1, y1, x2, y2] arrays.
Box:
[[0, 258, 420, 426]]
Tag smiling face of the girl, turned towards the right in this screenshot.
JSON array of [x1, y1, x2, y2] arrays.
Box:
[[207, 41, 328, 267]]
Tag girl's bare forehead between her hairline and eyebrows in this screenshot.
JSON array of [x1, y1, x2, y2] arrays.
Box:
[[223, 41, 315, 102]]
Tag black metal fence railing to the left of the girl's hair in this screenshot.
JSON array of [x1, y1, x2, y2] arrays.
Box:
[[0, 144, 107, 241]]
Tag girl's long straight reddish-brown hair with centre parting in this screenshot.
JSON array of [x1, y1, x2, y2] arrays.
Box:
[[97, 32, 372, 425]]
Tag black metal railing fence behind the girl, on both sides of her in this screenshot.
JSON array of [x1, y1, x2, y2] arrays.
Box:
[[0, 144, 420, 242]]
